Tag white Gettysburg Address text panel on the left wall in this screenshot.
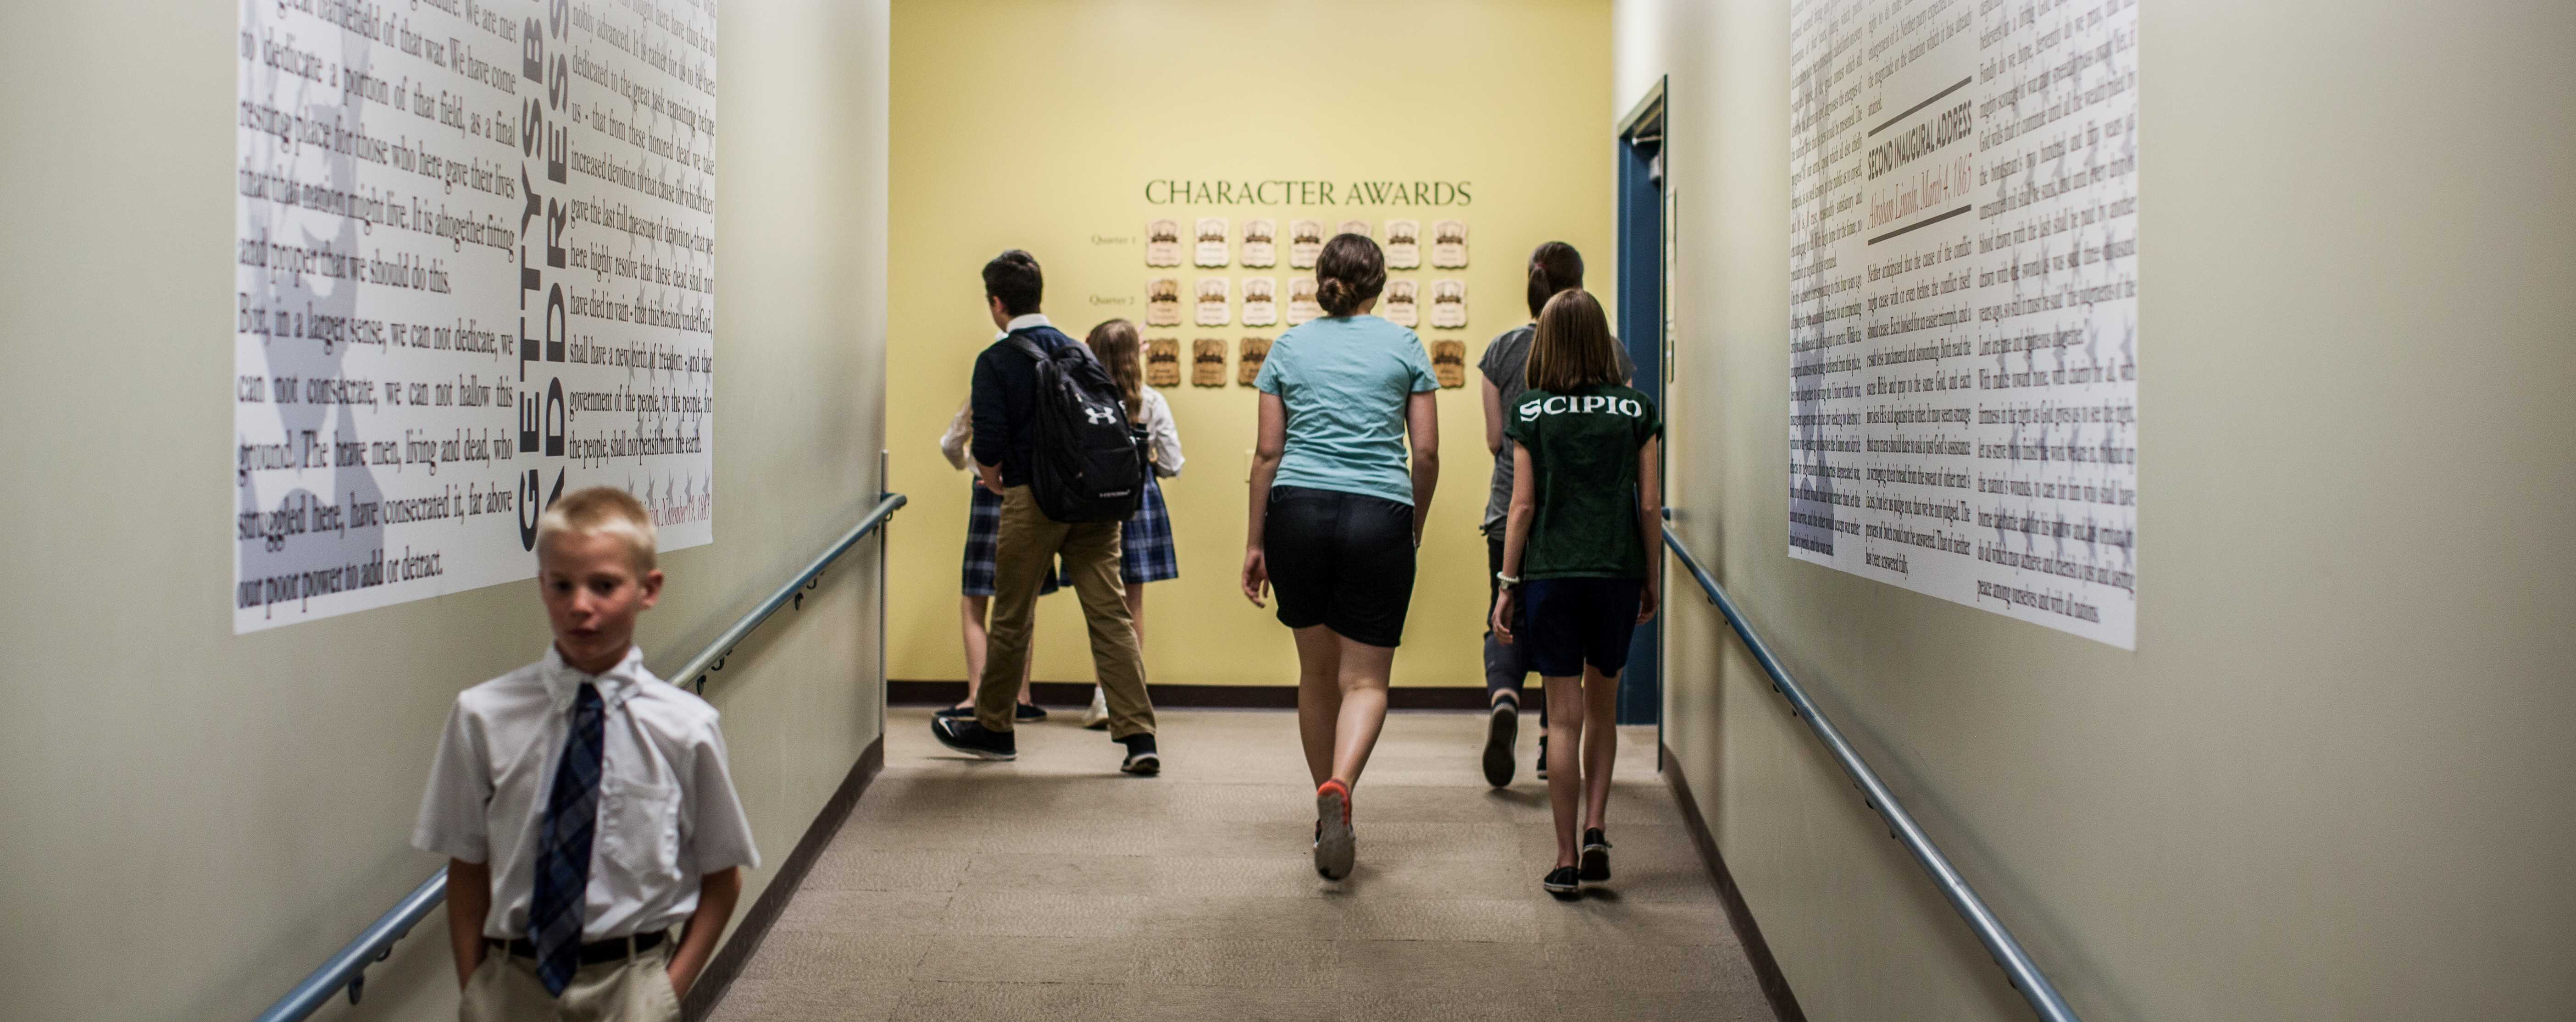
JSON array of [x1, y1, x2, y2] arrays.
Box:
[[229, 0, 716, 633]]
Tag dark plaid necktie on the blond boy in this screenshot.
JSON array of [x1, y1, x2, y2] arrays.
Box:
[[528, 682, 605, 996]]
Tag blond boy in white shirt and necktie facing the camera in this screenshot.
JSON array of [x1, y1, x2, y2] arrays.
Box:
[[412, 486, 760, 1022]]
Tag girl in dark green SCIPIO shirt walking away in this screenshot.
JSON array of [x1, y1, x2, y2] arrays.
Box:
[[1492, 288, 1664, 896]]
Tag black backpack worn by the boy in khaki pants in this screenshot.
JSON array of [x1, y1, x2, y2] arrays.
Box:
[[1010, 335, 1146, 523]]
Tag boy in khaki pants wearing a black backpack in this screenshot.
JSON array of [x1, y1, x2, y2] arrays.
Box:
[[930, 250, 1162, 775]]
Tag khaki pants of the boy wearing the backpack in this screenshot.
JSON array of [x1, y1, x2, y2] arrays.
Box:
[[974, 486, 1154, 739]]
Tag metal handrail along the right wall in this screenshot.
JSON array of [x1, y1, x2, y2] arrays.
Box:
[[1664, 525, 2079, 1022]]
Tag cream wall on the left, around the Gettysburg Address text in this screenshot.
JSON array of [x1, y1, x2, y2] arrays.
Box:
[[0, 0, 886, 1022]]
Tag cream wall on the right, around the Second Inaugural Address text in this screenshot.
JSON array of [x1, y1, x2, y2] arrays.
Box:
[[1628, 0, 2576, 1022]]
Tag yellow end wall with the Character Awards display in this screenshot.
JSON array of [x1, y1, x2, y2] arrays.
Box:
[[886, 0, 1615, 685]]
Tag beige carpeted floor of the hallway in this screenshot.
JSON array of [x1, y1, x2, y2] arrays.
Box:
[[714, 708, 1770, 1022]]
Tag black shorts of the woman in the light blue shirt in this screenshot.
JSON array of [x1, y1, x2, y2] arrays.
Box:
[[1262, 486, 1414, 646]]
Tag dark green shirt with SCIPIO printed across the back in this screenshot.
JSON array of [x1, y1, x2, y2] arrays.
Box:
[[1502, 386, 1664, 579]]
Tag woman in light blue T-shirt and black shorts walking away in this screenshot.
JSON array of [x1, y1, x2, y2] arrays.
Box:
[[1244, 234, 1440, 880]]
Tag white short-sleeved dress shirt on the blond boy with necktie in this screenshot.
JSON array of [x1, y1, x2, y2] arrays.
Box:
[[412, 646, 760, 939]]
